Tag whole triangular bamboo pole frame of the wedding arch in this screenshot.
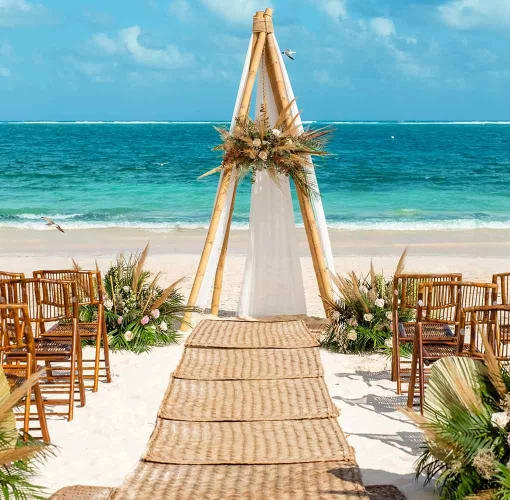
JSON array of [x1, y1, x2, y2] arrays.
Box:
[[181, 8, 333, 331]]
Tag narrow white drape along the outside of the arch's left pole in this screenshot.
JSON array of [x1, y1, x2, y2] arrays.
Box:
[[196, 36, 253, 309]]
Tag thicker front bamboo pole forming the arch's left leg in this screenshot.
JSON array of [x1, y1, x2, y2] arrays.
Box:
[[181, 12, 266, 331]]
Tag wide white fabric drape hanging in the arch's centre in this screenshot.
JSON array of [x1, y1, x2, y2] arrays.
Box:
[[237, 58, 306, 318]]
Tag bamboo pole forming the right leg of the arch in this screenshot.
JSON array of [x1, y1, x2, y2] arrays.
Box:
[[266, 23, 333, 314]]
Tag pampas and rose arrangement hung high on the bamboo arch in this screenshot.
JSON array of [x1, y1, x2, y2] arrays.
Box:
[[199, 101, 330, 198]]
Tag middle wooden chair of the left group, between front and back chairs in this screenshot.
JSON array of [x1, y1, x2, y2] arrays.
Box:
[[0, 278, 85, 421]]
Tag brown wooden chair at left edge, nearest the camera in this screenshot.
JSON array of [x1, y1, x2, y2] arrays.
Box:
[[0, 304, 50, 443]]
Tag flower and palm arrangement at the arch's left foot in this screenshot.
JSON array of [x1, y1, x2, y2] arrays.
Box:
[[104, 245, 194, 353]]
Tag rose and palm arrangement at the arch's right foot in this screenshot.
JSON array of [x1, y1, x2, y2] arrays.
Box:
[[322, 251, 413, 356]]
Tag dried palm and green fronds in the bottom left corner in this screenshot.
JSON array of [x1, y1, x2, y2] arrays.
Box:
[[0, 365, 52, 500]]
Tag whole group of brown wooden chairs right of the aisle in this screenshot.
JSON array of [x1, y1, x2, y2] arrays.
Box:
[[392, 273, 510, 411]]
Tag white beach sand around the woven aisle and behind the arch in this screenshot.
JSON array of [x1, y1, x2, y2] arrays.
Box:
[[0, 230, 510, 499]]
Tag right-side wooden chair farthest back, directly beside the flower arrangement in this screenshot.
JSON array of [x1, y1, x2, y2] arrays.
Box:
[[392, 273, 462, 394]]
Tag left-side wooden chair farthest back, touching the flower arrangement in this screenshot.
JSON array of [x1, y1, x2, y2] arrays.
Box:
[[33, 269, 111, 392]]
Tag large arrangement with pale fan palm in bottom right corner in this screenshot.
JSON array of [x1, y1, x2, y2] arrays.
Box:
[[405, 350, 510, 500]]
